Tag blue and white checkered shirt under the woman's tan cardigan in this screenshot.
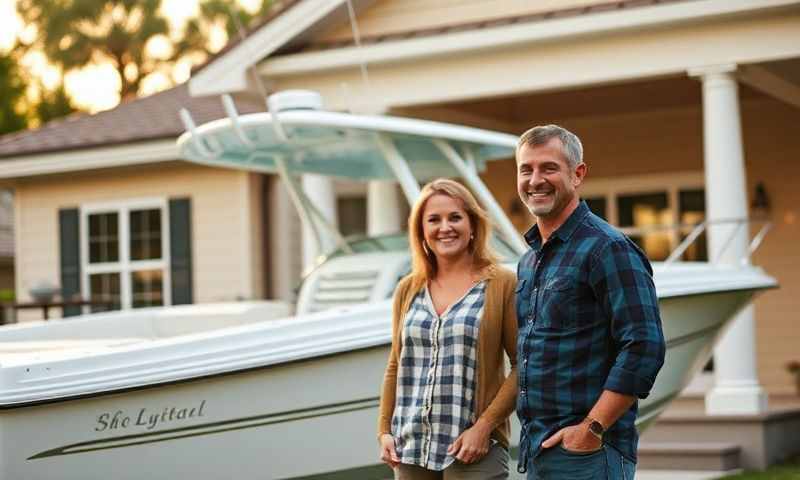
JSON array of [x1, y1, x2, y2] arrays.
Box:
[[392, 281, 486, 470]]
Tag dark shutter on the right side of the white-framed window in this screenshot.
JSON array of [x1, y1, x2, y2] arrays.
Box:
[[169, 198, 194, 305]]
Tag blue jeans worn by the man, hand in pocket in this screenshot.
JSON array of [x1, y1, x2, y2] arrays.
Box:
[[528, 444, 636, 480]]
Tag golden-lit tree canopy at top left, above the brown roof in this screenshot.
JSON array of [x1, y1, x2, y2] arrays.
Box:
[[17, 0, 270, 98]]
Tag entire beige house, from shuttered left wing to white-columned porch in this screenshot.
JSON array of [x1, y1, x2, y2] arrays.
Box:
[[0, 0, 800, 467]]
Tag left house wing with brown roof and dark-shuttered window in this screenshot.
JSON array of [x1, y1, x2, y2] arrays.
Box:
[[0, 85, 290, 321]]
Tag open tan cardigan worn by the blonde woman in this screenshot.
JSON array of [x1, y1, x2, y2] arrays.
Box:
[[378, 267, 517, 447]]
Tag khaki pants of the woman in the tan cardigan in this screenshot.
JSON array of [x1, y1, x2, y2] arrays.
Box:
[[394, 443, 508, 480]]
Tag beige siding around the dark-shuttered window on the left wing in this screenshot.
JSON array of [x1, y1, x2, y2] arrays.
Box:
[[15, 162, 262, 318]]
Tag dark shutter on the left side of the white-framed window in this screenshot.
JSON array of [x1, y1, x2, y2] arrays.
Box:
[[58, 208, 81, 317]]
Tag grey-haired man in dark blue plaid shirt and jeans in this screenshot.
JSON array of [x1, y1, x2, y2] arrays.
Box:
[[516, 125, 666, 480]]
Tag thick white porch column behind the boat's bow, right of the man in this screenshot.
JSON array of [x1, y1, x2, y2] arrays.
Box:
[[689, 65, 767, 415]]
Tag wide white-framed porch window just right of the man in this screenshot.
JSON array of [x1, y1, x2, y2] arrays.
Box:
[[581, 172, 707, 261]]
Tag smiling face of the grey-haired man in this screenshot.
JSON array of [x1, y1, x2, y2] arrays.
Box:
[[517, 138, 586, 219]]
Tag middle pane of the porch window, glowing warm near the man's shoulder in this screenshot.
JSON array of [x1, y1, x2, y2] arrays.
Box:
[[617, 192, 672, 260]]
